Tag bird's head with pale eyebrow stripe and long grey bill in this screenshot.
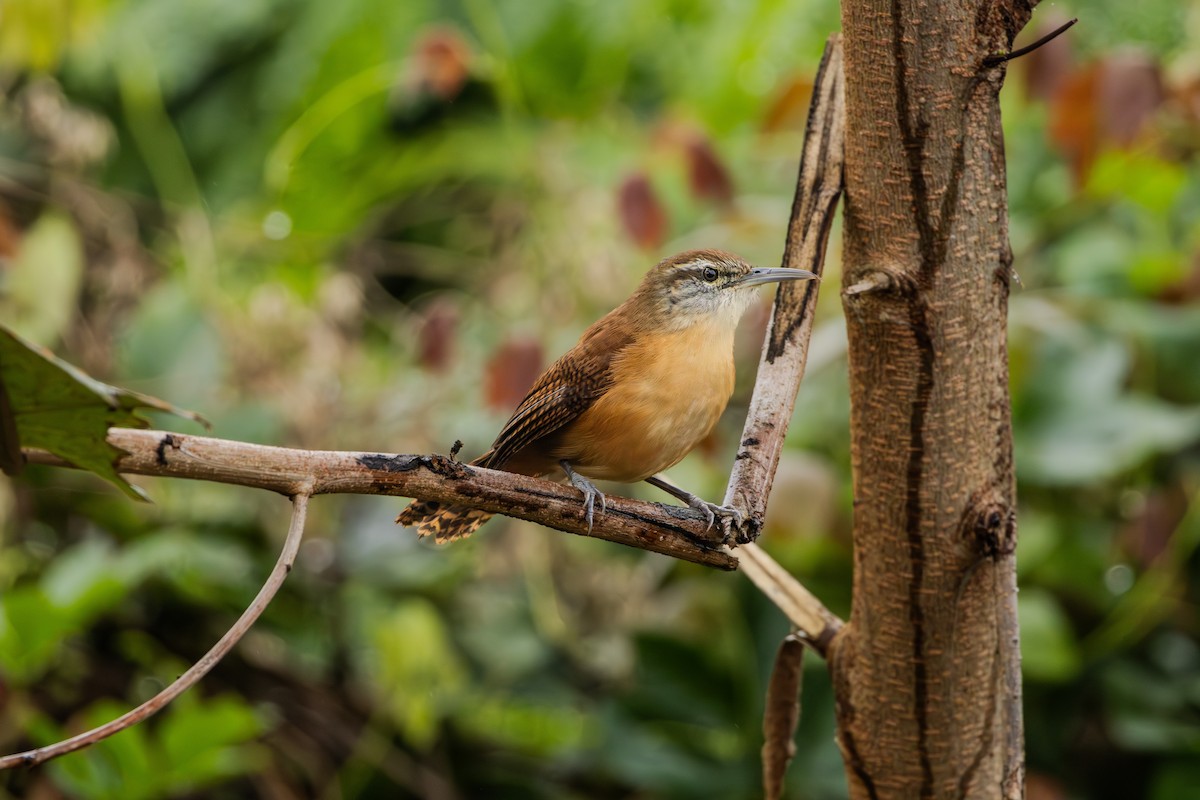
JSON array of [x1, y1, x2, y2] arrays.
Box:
[[635, 249, 817, 327]]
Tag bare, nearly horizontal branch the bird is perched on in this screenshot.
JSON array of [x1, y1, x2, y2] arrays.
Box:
[[26, 428, 737, 570]]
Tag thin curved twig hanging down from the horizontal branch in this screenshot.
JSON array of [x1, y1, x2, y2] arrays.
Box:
[[0, 492, 311, 769]]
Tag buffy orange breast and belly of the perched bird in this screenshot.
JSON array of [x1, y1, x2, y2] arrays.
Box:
[[554, 325, 733, 482]]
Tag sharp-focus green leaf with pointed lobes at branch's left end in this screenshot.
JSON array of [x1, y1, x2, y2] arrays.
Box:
[[0, 326, 208, 499]]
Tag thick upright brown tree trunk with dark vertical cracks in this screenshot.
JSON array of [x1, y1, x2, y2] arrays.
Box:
[[830, 0, 1033, 798]]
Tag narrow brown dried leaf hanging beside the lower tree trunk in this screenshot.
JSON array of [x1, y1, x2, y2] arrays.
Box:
[[762, 633, 804, 800]]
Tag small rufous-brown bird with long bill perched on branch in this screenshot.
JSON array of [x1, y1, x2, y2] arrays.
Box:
[[396, 249, 818, 543]]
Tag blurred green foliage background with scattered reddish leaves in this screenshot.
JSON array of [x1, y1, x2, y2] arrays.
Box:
[[0, 0, 1200, 800]]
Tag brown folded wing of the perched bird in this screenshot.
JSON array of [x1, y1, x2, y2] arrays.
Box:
[[485, 308, 632, 469]]
